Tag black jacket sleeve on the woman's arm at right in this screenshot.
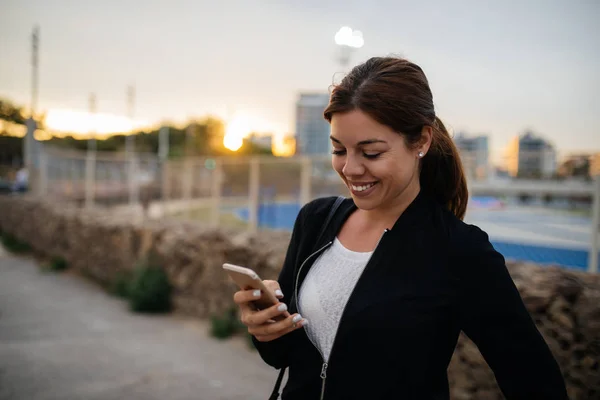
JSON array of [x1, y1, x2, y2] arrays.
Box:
[[459, 225, 568, 400]]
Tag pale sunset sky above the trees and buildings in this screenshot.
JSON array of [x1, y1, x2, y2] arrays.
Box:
[[0, 0, 600, 162]]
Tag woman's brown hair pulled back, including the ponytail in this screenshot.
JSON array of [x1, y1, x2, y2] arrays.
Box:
[[324, 57, 468, 219]]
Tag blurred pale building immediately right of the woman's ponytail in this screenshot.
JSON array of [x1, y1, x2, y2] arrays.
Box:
[[454, 132, 490, 179]]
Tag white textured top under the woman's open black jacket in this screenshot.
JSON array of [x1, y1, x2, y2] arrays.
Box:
[[298, 238, 373, 361]]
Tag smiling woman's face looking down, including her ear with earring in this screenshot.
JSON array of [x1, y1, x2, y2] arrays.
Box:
[[331, 110, 430, 210]]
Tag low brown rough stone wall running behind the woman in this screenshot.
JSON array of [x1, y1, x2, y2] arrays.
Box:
[[0, 197, 600, 400]]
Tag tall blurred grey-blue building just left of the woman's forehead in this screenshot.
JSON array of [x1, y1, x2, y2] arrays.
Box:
[[296, 93, 332, 155]]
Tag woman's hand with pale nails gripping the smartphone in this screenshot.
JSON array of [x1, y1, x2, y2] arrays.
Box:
[[233, 281, 308, 342]]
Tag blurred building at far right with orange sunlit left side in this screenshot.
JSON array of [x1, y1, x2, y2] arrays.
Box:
[[506, 131, 557, 178]]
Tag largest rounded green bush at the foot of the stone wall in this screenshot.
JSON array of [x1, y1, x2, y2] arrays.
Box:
[[126, 261, 172, 313]]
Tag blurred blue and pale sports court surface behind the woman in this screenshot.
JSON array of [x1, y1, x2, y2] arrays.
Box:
[[236, 198, 591, 270]]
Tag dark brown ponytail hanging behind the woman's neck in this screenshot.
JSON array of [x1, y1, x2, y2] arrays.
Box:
[[419, 117, 469, 220]]
